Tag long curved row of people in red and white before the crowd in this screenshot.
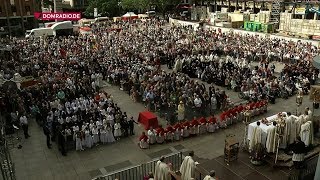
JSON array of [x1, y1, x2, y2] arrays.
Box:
[[139, 100, 268, 149]]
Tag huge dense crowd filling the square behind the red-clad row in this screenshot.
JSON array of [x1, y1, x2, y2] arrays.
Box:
[[0, 16, 319, 159]]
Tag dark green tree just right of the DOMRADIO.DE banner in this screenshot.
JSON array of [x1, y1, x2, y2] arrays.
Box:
[[85, 0, 121, 17]]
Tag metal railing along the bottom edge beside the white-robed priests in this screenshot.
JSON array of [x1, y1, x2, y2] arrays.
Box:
[[92, 152, 183, 180]]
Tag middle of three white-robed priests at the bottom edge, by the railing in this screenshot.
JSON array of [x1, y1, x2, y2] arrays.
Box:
[[180, 151, 197, 180]]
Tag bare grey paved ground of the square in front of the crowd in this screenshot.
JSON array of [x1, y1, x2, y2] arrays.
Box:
[[11, 62, 319, 180]]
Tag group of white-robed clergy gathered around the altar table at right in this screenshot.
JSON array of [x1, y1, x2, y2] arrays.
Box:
[[248, 107, 314, 166]]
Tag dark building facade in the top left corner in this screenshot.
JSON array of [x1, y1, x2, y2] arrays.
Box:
[[0, 0, 39, 36]]
